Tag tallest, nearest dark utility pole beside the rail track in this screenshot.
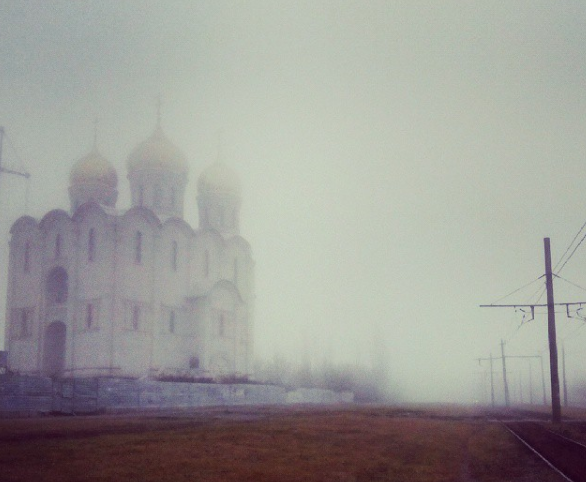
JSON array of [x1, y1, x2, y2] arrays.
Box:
[[543, 238, 562, 423]]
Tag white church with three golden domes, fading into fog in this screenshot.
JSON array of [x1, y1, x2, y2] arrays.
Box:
[[5, 115, 254, 380]]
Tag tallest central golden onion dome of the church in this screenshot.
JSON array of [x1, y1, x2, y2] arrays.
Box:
[[127, 125, 188, 173]]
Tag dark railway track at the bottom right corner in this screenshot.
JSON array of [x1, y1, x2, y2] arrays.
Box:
[[503, 422, 586, 482]]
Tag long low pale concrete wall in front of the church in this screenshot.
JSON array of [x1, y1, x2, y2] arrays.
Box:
[[0, 375, 354, 417]]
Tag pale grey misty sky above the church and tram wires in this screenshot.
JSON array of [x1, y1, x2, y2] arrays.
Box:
[[0, 0, 586, 401]]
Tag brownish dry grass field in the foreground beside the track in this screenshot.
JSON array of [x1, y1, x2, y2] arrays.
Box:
[[0, 407, 560, 482]]
